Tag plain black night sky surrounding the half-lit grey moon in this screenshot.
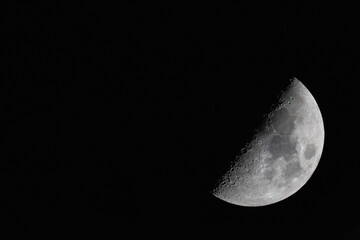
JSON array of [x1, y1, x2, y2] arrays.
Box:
[[0, 1, 360, 239]]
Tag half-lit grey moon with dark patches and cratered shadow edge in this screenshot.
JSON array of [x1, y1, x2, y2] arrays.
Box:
[[212, 78, 325, 207]]
